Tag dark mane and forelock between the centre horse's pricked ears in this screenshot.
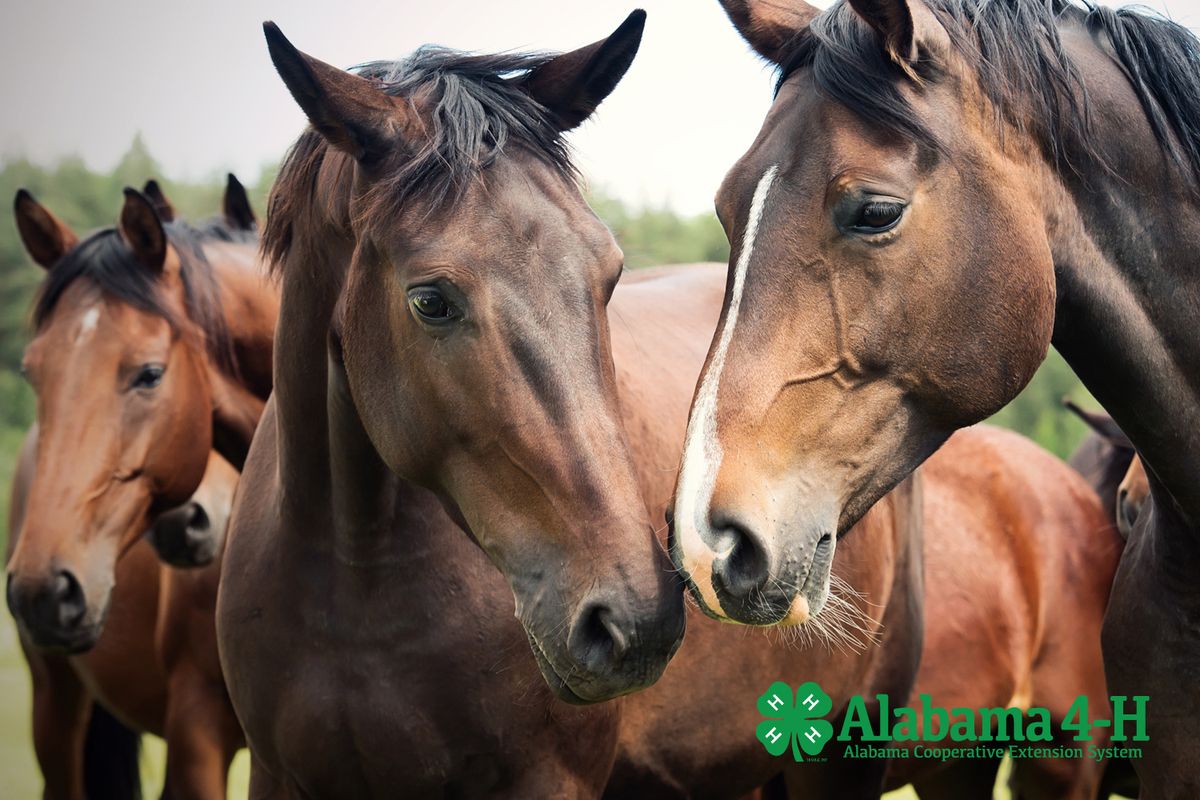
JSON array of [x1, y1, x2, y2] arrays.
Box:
[[263, 44, 577, 270]]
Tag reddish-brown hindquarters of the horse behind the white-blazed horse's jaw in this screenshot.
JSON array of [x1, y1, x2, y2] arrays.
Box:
[[890, 426, 1121, 800]]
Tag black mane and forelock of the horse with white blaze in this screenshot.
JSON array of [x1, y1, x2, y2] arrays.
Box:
[[776, 0, 1200, 190]]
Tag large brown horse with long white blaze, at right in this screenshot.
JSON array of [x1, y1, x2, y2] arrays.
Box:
[[676, 0, 1200, 796]]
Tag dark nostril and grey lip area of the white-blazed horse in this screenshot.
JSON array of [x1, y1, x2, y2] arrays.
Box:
[[710, 510, 792, 625]]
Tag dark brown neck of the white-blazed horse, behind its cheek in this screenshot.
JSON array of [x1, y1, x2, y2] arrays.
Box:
[[1044, 29, 1200, 528]]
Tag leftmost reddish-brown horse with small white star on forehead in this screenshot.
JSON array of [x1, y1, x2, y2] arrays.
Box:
[[7, 178, 278, 798]]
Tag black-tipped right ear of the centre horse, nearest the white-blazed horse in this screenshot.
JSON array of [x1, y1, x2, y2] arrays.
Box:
[[524, 8, 646, 131]]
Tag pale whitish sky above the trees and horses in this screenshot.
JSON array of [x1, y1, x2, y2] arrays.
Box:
[[0, 0, 1200, 213]]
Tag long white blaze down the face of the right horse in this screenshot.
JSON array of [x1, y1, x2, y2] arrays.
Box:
[[676, 164, 779, 612]]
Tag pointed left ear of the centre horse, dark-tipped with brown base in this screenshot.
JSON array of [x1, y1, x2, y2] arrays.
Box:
[[263, 22, 413, 162]]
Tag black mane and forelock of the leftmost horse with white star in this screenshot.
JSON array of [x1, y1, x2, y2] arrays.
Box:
[[34, 222, 238, 378]]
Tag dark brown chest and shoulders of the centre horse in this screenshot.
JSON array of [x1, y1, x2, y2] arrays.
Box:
[[217, 401, 616, 798]]
